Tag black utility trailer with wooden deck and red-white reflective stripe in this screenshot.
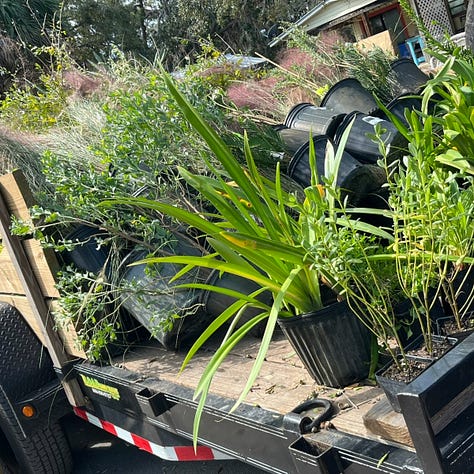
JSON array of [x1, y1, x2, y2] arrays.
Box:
[[0, 173, 474, 474]]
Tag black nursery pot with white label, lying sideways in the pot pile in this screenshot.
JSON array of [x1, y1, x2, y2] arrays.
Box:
[[334, 111, 407, 164]]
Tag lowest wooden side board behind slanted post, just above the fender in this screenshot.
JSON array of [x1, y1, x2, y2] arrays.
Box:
[[0, 294, 86, 359]]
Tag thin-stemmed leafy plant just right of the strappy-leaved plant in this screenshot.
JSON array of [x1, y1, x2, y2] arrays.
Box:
[[300, 120, 422, 377]]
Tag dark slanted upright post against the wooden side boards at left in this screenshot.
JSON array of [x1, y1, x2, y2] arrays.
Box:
[[0, 183, 86, 406]]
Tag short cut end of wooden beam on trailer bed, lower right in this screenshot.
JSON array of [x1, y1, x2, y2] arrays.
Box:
[[363, 396, 413, 447]]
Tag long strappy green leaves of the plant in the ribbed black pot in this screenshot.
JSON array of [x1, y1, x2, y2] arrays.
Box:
[[107, 69, 390, 441]]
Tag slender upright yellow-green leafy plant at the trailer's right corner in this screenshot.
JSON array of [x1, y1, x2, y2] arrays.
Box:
[[368, 58, 473, 411]]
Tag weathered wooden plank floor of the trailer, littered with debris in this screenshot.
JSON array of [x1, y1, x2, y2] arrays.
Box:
[[112, 332, 411, 446]]
